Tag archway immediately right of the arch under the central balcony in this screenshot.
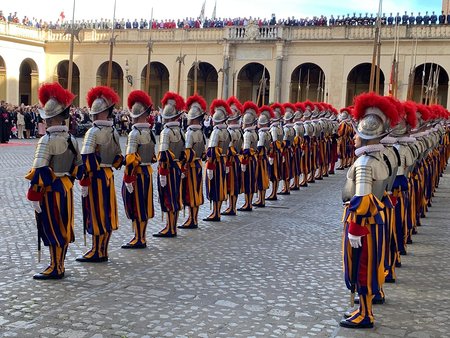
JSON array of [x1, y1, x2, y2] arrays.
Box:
[[290, 63, 326, 102]]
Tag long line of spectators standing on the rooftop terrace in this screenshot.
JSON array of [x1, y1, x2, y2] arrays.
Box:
[[0, 10, 450, 29]]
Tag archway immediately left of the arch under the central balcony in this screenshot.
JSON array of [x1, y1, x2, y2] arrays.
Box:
[[187, 62, 218, 103]]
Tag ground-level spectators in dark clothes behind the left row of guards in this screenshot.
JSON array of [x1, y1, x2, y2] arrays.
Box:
[[0, 101, 216, 143]]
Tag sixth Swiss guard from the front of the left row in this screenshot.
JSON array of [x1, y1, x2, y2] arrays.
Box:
[[203, 100, 233, 222]]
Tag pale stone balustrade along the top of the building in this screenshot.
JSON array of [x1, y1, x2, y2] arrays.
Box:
[[0, 21, 450, 43]]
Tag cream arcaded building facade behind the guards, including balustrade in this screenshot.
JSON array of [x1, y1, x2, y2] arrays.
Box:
[[0, 22, 450, 107]]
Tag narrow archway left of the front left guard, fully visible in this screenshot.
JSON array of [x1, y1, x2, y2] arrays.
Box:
[[19, 59, 39, 105]]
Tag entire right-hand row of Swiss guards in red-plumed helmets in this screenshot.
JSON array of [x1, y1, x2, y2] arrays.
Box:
[[338, 93, 450, 328]]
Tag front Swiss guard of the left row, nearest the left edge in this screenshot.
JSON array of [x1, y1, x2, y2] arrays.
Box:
[[25, 83, 82, 279]]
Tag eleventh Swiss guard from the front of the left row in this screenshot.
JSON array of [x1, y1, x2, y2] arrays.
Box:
[[278, 102, 296, 195]]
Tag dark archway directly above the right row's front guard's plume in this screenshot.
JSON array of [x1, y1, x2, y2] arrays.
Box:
[[345, 62, 384, 106]]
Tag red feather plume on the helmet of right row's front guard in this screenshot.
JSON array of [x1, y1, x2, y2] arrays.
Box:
[[352, 93, 399, 127]]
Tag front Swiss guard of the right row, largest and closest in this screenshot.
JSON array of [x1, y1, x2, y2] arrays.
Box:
[[340, 93, 398, 328]]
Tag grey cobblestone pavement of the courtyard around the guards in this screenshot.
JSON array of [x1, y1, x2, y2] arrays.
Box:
[[0, 138, 450, 338]]
